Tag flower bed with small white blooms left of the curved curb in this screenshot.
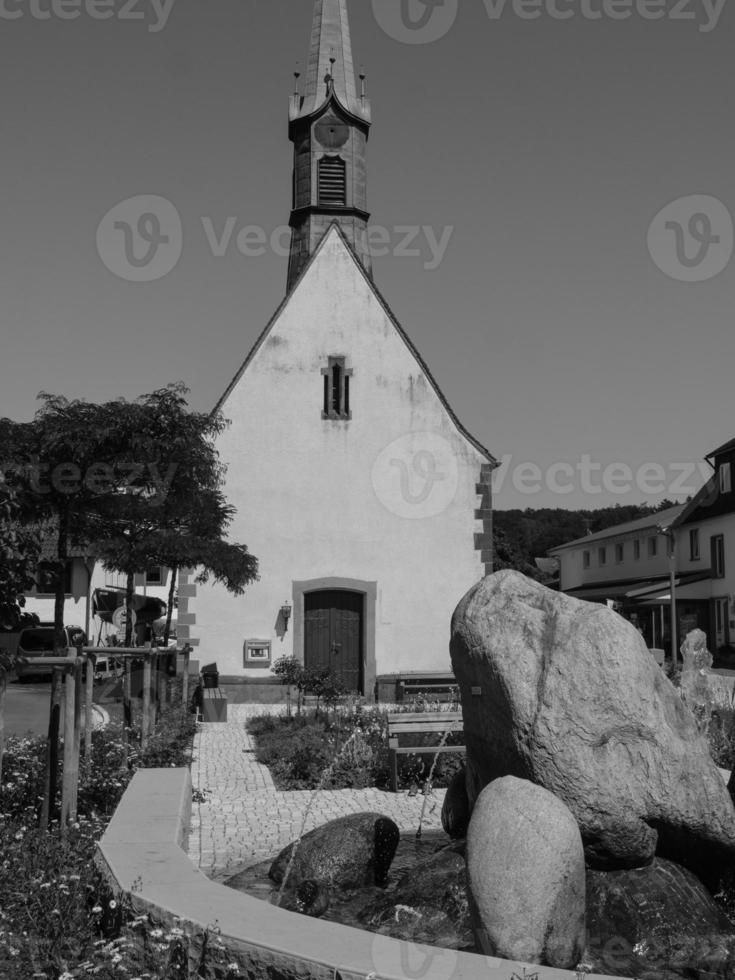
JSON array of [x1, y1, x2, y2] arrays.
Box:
[[0, 684, 195, 980]]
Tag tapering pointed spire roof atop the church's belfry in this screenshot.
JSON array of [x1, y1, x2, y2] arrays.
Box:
[[291, 0, 370, 121]]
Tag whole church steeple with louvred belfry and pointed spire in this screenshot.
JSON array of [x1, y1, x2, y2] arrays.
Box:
[[288, 0, 372, 290]]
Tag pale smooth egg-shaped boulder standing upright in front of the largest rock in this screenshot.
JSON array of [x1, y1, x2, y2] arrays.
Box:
[[467, 776, 585, 969]]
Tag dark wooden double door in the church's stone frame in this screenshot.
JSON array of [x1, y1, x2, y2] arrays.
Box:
[[304, 589, 364, 692]]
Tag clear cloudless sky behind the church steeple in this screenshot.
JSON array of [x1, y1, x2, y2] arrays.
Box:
[[0, 0, 735, 508]]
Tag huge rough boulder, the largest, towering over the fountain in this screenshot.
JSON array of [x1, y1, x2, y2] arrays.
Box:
[[451, 571, 735, 885]]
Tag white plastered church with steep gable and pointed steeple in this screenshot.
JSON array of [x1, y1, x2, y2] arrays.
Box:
[[184, 0, 496, 700]]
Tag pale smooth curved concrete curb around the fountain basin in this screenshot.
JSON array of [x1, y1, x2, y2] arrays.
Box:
[[96, 769, 620, 980]]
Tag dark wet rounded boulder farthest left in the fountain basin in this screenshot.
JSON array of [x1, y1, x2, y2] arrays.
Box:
[[268, 813, 400, 888]]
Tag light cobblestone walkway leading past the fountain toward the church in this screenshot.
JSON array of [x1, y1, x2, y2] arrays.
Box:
[[189, 704, 444, 878]]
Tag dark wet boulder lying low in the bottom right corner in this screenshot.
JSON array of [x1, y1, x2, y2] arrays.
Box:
[[585, 858, 735, 980]]
